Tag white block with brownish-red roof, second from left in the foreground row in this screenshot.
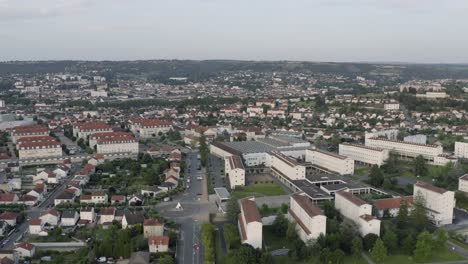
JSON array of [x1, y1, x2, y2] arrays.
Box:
[[288, 193, 327, 243]]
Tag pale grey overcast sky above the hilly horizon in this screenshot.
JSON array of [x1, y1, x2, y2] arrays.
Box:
[[0, 0, 468, 63]]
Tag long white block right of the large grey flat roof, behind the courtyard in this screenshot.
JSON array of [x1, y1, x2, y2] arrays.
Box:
[[305, 149, 354, 175]]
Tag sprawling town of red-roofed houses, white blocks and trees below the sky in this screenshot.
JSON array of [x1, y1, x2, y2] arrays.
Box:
[[0, 61, 468, 264]]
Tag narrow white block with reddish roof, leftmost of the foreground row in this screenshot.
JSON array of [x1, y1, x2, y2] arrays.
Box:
[[238, 197, 263, 248]]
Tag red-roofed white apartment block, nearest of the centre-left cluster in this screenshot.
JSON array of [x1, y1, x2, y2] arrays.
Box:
[[96, 137, 138, 154]]
